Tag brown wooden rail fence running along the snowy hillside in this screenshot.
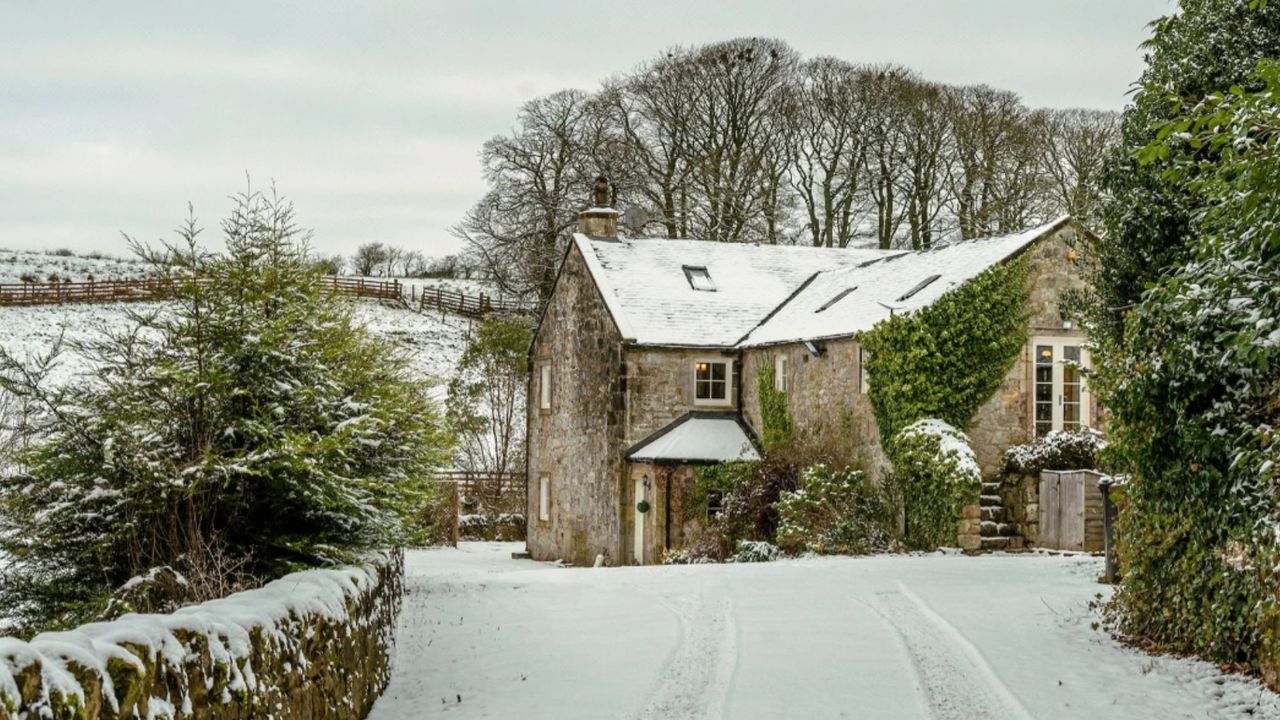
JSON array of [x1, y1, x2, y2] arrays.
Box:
[[0, 275, 530, 318]]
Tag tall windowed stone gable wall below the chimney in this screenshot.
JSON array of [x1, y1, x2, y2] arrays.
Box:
[[527, 246, 626, 565]]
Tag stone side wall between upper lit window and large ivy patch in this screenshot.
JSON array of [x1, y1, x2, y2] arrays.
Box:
[[742, 338, 884, 477]]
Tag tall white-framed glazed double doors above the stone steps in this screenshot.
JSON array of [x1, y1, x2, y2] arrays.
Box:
[[1032, 337, 1091, 437]]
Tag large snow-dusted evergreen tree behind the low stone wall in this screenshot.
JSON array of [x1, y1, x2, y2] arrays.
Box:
[[0, 192, 449, 626]]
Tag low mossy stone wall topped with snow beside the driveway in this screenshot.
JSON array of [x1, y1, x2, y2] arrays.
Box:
[[0, 551, 404, 720]]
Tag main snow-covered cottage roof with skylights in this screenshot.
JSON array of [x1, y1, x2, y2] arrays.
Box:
[[575, 217, 1069, 347]]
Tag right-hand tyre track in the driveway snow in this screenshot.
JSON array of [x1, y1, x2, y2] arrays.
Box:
[[873, 580, 1033, 720]]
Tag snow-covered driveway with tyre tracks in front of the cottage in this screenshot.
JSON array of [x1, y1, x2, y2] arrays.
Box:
[[371, 543, 1280, 720]]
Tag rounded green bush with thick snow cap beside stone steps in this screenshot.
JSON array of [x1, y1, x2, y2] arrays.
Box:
[[886, 418, 982, 550]]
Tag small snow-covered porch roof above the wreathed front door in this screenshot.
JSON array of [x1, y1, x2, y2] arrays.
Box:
[[627, 413, 760, 462]]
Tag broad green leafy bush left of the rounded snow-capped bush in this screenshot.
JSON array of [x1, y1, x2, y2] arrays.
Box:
[[777, 465, 895, 555]]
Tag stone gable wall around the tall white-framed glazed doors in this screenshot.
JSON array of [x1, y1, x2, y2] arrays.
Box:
[[968, 225, 1097, 478]]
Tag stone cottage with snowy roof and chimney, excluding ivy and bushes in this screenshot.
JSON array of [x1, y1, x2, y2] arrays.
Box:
[[527, 198, 1096, 565]]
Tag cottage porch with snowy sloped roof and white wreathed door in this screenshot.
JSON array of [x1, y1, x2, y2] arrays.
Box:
[[622, 411, 760, 565]]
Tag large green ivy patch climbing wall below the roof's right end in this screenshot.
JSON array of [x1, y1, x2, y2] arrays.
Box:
[[859, 255, 1029, 448]]
